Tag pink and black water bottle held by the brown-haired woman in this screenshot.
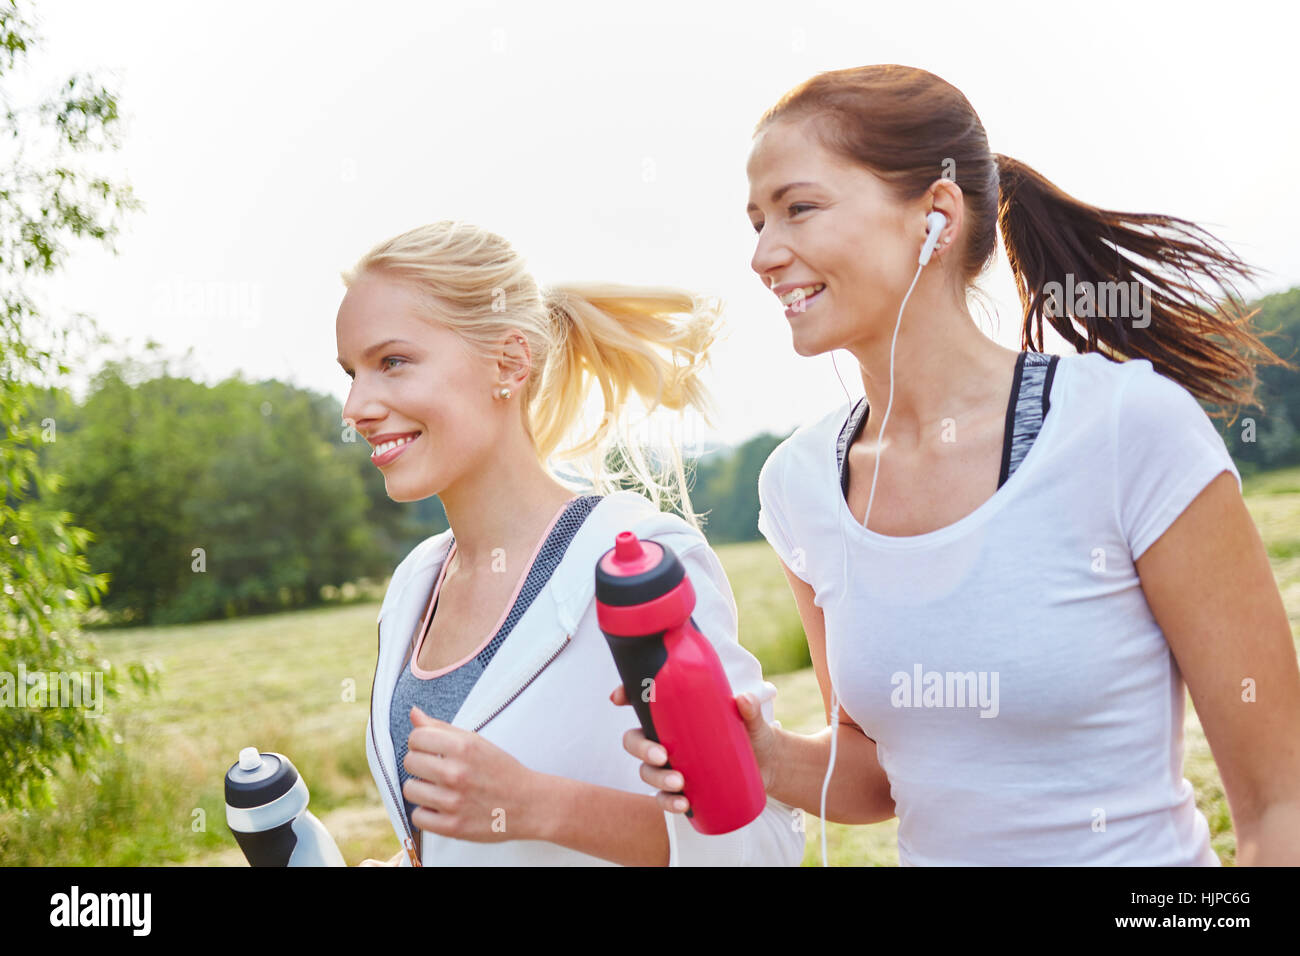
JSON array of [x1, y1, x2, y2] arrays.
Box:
[[595, 531, 767, 834]]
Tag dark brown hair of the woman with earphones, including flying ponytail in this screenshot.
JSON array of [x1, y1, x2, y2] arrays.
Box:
[[754, 64, 1295, 424]]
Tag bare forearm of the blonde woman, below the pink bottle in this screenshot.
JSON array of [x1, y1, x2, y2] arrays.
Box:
[[529, 774, 668, 866]]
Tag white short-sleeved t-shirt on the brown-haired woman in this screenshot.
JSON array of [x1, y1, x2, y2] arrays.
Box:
[[758, 352, 1240, 866]]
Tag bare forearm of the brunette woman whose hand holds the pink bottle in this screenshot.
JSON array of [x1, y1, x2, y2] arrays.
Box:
[[767, 724, 894, 823]]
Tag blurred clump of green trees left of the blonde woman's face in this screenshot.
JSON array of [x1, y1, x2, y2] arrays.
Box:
[[44, 356, 400, 624]]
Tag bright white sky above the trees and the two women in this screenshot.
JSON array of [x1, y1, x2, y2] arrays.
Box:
[[20, 0, 1300, 442]]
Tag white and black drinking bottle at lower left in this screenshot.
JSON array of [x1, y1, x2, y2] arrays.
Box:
[[226, 747, 347, 866]]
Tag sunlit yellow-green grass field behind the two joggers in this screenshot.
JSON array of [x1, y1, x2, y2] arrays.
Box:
[[0, 470, 1300, 866]]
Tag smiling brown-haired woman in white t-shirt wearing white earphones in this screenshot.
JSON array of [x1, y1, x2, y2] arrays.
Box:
[[627, 65, 1300, 866]]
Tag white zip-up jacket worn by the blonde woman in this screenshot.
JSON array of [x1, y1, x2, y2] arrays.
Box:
[[365, 492, 805, 866]]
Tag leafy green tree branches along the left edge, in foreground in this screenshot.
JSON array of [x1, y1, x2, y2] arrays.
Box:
[[0, 0, 152, 809]]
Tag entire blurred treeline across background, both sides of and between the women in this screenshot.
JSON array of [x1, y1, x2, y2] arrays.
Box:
[[20, 289, 1300, 624]]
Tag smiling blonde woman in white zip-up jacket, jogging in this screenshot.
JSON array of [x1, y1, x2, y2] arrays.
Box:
[[337, 222, 803, 865]]
